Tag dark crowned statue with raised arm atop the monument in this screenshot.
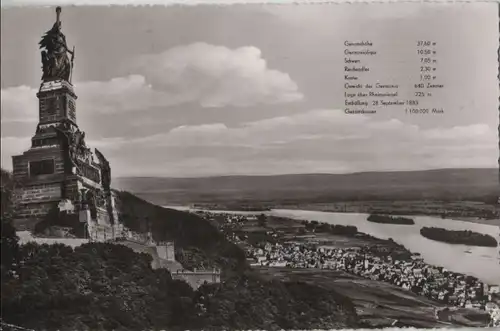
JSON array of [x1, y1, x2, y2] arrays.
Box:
[[38, 7, 75, 82]]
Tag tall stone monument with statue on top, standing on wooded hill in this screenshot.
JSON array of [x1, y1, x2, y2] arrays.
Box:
[[13, 7, 118, 241]]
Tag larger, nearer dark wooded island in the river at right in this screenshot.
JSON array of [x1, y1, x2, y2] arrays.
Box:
[[420, 227, 498, 247]]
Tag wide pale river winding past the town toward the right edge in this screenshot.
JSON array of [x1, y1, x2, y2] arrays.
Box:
[[165, 206, 500, 284]]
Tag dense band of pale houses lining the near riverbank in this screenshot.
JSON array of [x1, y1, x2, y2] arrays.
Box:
[[250, 242, 498, 309]]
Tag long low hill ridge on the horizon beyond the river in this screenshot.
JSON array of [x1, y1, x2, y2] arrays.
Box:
[[113, 169, 500, 205]]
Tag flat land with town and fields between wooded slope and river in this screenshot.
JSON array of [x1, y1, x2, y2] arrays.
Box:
[[190, 210, 496, 328]]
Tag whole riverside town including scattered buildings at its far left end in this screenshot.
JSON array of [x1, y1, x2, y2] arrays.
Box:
[[197, 211, 500, 327]]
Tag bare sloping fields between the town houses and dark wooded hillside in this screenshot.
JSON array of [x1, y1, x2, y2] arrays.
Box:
[[255, 267, 486, 328]]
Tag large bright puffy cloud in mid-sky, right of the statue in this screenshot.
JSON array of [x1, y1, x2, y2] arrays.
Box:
[[138, 43, 303, 107]]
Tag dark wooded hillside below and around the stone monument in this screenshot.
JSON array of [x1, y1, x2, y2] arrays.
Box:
[[1, 171, 358, 331]]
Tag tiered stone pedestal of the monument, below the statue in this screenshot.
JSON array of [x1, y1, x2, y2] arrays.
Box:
[[13, 80, 115, 235]]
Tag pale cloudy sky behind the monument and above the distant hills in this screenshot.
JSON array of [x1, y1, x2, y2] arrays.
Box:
[[1, 4, 499, 177]]
